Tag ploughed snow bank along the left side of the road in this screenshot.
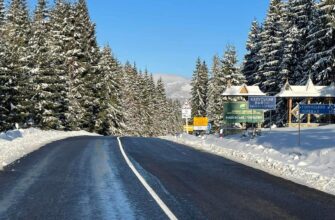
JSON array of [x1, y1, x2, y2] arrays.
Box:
[[0, 128, 94, 170]]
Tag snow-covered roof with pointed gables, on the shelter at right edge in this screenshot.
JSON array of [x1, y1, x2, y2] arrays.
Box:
[[276, 78, 335, 98]]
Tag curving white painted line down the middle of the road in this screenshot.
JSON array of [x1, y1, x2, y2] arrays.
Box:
[[117, 137, 177, 220]]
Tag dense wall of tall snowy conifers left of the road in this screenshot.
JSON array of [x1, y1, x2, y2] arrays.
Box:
[[0, 0, 182, 136]]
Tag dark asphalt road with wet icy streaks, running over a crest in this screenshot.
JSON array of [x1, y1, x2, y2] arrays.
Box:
[[0, 137, 335, 220]]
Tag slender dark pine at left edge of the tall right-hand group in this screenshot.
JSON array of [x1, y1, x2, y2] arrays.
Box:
[[242, 20, 262, 85]]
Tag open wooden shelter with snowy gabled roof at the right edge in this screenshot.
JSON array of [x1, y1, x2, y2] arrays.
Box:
[[276, 78, 335, 127]]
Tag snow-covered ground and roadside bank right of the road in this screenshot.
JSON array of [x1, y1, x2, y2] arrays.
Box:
[[164, 125, 335, 195]]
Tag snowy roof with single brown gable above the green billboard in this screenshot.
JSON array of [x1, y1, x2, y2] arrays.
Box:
[[222, 84, 265, 96]]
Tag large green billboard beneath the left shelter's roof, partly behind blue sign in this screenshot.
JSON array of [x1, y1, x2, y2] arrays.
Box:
[[223, 102, 264, 124]]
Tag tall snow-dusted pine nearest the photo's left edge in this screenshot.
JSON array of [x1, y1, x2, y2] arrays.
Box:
[[2, 0, 34, 127]]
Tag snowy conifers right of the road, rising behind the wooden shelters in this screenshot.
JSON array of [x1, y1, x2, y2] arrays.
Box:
[[192, 0, 335, 128]]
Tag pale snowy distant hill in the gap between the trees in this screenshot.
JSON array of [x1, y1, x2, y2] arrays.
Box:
[[154, 73, 191, 101]]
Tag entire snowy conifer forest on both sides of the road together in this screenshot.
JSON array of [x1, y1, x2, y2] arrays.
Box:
[[0, 0, 335, 136]]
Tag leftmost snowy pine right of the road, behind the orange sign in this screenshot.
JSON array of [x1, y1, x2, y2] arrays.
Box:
[[191, 58, 208, 117]]
